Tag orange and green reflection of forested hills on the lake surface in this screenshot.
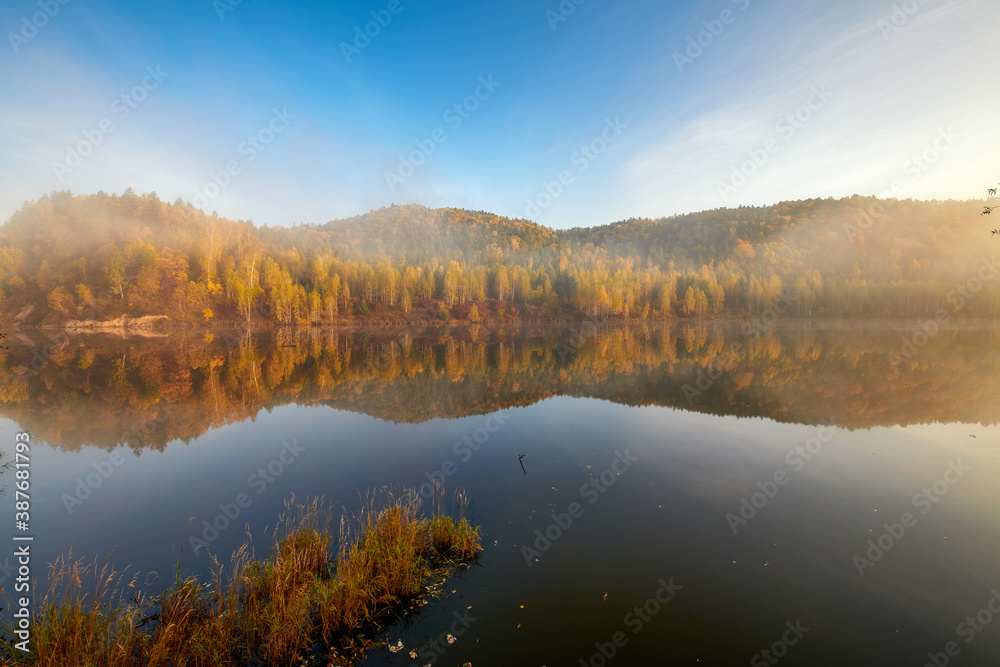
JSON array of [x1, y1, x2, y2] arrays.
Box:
[[0, 322, 1000, 450]]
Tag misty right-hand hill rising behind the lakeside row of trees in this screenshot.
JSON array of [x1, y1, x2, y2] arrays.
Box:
[[558, 196, 990, 281]]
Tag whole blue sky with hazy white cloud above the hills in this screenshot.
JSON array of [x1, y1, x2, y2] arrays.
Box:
[[0, 0, 1000, 227]]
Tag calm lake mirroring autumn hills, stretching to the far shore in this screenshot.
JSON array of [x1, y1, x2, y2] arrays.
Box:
[[0, 322, 1000, 667]]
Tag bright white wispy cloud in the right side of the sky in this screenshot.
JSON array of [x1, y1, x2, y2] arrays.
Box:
[[624, 0, 1000, 215]]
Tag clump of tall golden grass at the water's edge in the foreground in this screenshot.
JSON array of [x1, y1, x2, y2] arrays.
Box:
[[0, 490, 482, 667]]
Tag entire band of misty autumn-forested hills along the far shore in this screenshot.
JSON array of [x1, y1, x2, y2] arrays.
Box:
[[0, 190, 1000, 325]]
